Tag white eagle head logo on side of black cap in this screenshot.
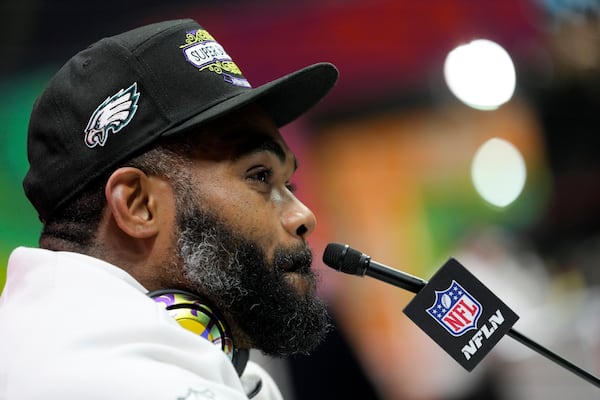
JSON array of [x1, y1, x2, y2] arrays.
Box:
[[84, 82, 140, 148]]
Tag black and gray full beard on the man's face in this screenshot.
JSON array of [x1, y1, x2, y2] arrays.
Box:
[[178, 206, 330, 356]]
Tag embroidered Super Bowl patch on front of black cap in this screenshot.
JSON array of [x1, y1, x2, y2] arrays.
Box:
[[179, 29, 251, 87]]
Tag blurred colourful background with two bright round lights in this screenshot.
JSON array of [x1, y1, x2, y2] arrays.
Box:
[[0, 0, 600, 400]]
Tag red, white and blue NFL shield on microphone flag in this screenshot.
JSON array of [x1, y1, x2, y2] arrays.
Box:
[[427, 280, 482, 336]]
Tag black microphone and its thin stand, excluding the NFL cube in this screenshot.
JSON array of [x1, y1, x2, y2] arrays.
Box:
[[323, 243, 600, 387]]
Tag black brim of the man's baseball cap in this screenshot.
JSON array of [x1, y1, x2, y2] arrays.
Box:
[[162, 63, 338, 136]]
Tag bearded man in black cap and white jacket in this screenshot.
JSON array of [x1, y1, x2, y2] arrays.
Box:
[[0, 20, 337, 400]]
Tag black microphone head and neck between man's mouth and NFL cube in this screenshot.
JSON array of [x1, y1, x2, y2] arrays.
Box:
[[323, 243, 427, 293]]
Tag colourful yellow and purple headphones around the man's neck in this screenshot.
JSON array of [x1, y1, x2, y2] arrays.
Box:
[[148, 289, 249, 376]]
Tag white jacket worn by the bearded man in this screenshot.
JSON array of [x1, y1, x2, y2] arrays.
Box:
[[0, 247, 281, 400]]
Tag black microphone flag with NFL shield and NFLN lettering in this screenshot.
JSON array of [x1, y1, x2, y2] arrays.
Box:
[[403, 258, 519, 371]]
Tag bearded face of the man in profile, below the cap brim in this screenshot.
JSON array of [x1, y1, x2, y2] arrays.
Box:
[[168, 104, 328, 355]]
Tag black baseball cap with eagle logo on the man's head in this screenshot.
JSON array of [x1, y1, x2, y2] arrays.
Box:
[[23, 19, 338, 221]]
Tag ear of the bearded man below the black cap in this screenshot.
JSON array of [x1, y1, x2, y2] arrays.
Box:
[[105, 167, 164, 239]]
